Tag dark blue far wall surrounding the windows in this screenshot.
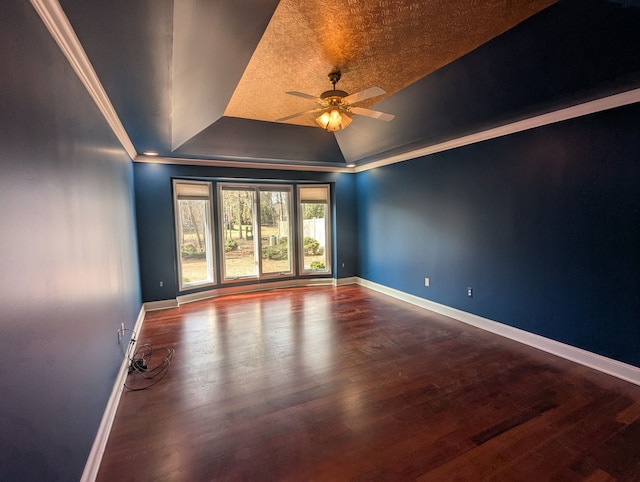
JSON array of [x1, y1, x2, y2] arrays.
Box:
[[134, 163, 358, 302]]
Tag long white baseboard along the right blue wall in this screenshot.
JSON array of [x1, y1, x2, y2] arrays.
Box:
[[358, 278, 640, 385]]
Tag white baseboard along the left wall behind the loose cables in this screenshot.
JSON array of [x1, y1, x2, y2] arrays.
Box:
[[80, 305, 146, 482]]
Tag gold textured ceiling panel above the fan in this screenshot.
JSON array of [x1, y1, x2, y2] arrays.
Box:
[[224, 0, 556, 126]]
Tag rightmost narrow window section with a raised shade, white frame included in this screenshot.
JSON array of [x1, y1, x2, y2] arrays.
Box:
[[298, 185, 331, 274]]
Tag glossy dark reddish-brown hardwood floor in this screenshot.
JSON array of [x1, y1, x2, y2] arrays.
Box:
[[98, 285, 640, 481]]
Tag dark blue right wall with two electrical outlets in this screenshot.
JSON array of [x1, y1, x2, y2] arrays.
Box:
[[357, 104, 640, 366]]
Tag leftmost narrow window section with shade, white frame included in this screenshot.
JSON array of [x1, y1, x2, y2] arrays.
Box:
[[173, 181, 215, 290]]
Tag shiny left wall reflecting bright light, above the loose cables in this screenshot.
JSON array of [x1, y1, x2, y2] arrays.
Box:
[[0, 0, 140, 481]]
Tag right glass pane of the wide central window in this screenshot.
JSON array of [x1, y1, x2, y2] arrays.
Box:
[[260, 190, 292, 274]]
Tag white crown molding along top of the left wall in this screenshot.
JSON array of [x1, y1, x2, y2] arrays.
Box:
[[31, 0, 138, 159]]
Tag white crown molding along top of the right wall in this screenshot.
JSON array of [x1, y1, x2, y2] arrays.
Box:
[[354, 89, 640, 172]]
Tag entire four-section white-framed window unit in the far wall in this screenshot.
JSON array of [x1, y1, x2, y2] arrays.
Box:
[[173, 179, 332, 291]]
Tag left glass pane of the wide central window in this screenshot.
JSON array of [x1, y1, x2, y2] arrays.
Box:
[[221, 186, 258, 279]]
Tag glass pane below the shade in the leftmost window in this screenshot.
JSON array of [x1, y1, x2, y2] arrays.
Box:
[[177, 199, 213, 287]]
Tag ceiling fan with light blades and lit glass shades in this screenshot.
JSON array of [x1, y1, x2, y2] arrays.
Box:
[[276, 70, 395, 131]]
